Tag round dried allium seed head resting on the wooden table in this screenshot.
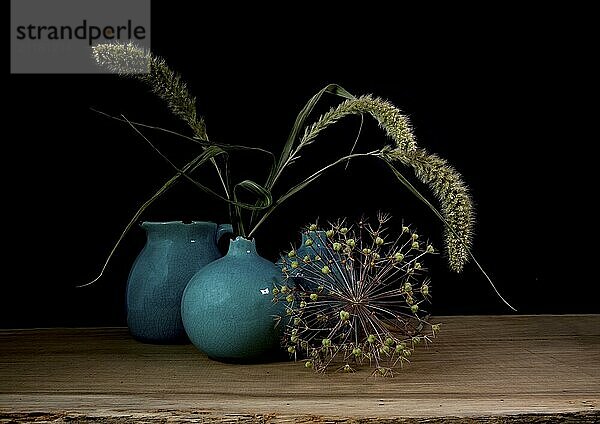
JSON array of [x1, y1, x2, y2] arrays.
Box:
[[274, 217, 439, 376]]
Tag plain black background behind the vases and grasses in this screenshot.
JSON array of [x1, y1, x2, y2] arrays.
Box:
[[0, 1, 600, 327]]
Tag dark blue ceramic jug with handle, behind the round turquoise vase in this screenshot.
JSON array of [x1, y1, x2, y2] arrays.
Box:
[[127, 221, 232, 343]]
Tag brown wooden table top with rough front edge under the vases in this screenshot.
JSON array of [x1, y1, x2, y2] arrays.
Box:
[[0, 315, 600, 423]]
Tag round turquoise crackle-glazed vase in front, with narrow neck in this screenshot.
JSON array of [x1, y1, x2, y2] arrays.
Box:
[[181, 237, 285, 363]]
